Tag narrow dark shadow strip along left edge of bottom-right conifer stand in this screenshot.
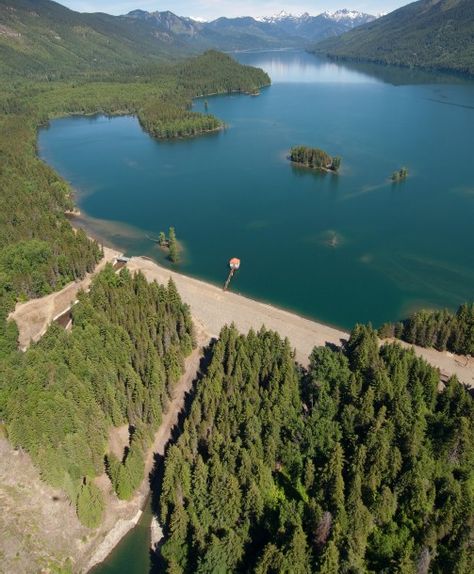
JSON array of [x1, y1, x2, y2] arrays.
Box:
[[149, 339, 217, 574]]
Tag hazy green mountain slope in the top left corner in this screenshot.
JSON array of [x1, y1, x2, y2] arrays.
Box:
[[0, 0, 189, 77]]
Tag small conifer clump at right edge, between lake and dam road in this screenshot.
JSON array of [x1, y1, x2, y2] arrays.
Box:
[[379, 303, 474, 356]]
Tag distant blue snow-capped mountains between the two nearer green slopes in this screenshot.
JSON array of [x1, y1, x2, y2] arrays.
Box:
[[124, 10, 375, 50]]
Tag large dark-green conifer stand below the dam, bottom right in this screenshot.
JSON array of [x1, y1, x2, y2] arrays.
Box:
[[160, 326, 474, 574]]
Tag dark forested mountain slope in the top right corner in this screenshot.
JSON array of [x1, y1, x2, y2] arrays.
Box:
[[313, 0, 474, 75]]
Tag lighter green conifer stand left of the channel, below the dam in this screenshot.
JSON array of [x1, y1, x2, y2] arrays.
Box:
[[0, 266, 195, 527]]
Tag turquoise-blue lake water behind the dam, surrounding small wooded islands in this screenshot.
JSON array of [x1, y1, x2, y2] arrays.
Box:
[[39, 52, 474, 328]]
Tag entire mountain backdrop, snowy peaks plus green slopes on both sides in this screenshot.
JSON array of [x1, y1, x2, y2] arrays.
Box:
[[5, 0, 474, 78]]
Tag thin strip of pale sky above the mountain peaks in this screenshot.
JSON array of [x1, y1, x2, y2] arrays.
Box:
[[57, 0, 410, 20]]
